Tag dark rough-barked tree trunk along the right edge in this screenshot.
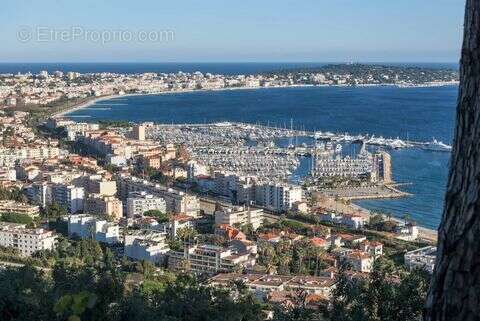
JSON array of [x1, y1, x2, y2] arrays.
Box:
[[425, 0, 480, 321]]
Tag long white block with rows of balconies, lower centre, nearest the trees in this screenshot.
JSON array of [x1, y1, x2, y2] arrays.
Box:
[[168, 244, 256, 274]]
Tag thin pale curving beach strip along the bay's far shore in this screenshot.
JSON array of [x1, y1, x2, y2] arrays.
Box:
[[58, 81, 459, 117]]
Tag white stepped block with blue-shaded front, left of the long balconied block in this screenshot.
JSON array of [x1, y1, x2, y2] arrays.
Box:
[[124, 230, 170, 264]]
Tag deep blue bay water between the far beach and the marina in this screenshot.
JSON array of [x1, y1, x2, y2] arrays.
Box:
[[70, 86, 457, 228]]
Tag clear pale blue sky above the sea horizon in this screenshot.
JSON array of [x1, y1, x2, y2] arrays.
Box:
[[0, 0, 465, 62]]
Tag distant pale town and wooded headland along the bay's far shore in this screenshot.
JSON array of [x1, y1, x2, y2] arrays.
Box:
[[0, 64, 458, 106]]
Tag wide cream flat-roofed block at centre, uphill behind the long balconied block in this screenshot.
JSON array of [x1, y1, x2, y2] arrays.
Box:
[[215, 206, 263, 230]]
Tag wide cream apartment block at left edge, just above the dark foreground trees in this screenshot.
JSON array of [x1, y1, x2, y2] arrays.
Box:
[[0, 222, 56, 256]]
